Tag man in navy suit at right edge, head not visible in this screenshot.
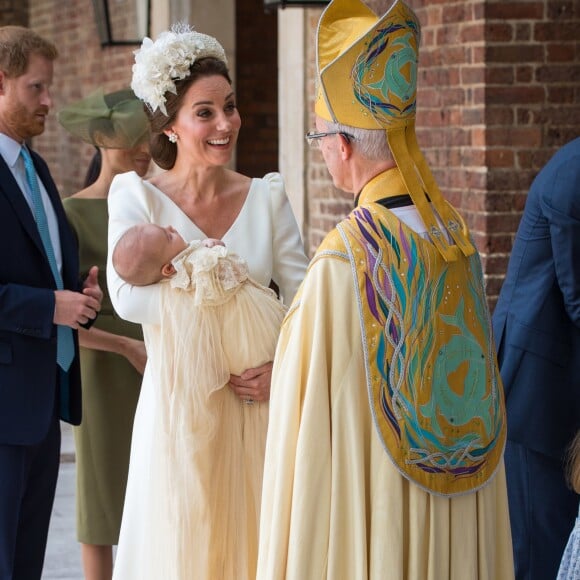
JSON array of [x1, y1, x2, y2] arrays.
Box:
[[493, 138, 580, 580]]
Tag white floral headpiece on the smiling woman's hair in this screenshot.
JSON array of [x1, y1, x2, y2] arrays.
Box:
[[131, 23, 227, 115]]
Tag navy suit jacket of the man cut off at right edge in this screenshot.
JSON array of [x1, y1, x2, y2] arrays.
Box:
[[493, 138, 580, 459]]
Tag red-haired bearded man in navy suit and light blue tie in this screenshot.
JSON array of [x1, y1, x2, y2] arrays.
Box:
[[0, 26, 102, 580]]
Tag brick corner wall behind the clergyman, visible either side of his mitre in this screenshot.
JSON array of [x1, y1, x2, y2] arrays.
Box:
[[307, 0, 580, 305]]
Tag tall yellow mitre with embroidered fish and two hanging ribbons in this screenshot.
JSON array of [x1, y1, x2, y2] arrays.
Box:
[[315, 0, 475, 261]]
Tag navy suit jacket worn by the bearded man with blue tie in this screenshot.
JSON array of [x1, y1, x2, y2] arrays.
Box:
[[0, 146, 81, 445]]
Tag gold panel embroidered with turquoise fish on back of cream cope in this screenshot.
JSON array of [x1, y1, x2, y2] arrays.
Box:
[[322, 204, 505, 495]]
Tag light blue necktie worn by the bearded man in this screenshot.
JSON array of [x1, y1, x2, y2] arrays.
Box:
[[20, 146, 75, 372]]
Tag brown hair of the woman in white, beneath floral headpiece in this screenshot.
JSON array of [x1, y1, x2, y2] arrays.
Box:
[[145, 57, 232, 169]]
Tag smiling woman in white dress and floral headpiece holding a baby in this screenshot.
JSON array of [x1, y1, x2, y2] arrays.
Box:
[[107, 27, 307, 580]]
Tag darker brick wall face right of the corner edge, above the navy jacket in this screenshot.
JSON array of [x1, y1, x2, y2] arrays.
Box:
[[480, 0, 580, 299]]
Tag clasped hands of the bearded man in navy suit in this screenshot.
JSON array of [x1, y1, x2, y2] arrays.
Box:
[[53, 266, 103, 330]]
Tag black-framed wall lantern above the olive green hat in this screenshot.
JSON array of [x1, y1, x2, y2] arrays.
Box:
[[93, 0, 151, 46]]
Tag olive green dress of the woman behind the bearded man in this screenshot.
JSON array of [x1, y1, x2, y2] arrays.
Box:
[[64, 197, 142, 545]]
